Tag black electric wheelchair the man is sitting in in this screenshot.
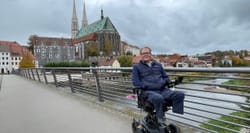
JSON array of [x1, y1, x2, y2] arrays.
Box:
[[132, 77, 183, 133]]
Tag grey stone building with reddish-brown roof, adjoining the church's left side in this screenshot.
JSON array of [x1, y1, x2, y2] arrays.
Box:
[[31, 36, 75, 67]]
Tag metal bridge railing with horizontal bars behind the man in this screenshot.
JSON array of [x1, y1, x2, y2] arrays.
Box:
[[16, 67, 250, 133]]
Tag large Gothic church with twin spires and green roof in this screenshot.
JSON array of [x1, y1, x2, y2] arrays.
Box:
[[71, 0, 121, 60]]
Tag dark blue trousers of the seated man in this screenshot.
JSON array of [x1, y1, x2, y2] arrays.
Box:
[[145, 89, 185, 118]]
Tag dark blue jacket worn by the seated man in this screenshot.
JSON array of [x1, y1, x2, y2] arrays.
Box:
[[132, 61, 170, 90]]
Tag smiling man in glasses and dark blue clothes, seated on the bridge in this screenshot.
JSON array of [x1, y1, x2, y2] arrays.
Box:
[[132, 47, 185, 123]]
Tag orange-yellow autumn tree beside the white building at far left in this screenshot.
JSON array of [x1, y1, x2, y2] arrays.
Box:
[[19, 52, 35, 68]]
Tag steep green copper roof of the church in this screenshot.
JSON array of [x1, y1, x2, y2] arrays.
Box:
[[76, 17, 117, 38]]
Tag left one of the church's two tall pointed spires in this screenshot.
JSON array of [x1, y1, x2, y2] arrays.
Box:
[[71, 0, 78, 38]]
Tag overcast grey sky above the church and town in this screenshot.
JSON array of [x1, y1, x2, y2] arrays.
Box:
[[0, 0, 250, 55]]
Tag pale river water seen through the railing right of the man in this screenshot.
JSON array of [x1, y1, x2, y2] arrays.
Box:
[[166, 79, 246, 126]]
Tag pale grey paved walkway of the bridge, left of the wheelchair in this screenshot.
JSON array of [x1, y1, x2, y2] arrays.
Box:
[[0, 75, 131, 133]]
